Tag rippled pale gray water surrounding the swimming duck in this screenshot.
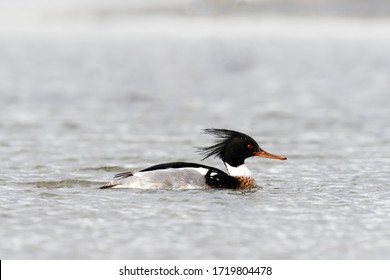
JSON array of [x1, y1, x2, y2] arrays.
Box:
[[0, 18, 390, 259]]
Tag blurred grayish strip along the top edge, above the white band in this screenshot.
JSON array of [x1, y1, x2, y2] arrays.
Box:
[[1, 0, 390, 19]]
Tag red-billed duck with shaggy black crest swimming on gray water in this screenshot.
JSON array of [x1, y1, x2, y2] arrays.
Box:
[[101, 129, 287, 190]]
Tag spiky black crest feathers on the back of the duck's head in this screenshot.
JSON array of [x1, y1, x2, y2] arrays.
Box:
[[197, 128, 255, 160]]
